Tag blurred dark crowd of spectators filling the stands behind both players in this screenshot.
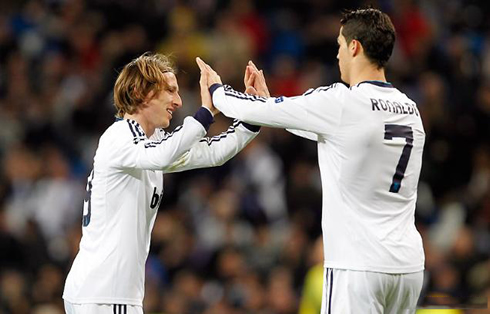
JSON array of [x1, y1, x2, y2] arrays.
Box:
[[0, 0, 490, 314]]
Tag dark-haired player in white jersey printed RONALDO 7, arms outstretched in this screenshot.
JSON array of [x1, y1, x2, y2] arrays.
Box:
[[198, 8, 425, 314]]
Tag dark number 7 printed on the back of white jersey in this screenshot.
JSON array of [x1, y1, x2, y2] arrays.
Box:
[[385, 124, 413, 193]]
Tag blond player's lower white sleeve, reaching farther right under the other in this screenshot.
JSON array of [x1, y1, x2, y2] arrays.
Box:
[[167, 120, 259, 172]]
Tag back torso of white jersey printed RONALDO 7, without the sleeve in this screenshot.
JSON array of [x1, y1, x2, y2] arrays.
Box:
[[318, 82, 425, 273]]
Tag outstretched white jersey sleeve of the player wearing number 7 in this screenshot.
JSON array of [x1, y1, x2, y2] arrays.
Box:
[[210, 84, 346, 136]]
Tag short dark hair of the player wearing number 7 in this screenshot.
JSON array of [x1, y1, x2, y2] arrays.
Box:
[[340, 8, 395, 68]]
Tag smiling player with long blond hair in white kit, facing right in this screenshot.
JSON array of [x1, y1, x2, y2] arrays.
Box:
[[63, 54, 259, 314]]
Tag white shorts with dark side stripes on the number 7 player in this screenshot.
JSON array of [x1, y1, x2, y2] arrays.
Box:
[[321, 268, 424, 314]]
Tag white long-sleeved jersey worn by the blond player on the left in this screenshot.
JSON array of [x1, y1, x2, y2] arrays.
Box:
[[63, 109, 258, 306]]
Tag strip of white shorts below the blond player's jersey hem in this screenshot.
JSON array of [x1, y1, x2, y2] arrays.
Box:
[[65, 300, 143, 314]]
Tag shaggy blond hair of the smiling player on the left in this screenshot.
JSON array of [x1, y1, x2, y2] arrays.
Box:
[[114, 52, 176, 118]]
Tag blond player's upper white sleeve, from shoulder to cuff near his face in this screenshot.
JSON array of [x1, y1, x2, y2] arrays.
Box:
[[110, 117, 206, 170]]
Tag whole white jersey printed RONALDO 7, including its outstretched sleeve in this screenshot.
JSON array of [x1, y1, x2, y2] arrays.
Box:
[[210, 81, 425, 273]]
